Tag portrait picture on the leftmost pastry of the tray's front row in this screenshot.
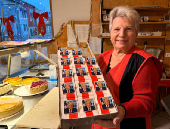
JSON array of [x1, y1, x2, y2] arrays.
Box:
[[64, 100, 78, 114]]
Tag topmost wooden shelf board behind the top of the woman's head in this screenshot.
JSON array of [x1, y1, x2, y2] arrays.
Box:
[[103, 6, 170, 11]]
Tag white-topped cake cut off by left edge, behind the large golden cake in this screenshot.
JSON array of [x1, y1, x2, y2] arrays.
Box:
[[0, 82, 11, 95]]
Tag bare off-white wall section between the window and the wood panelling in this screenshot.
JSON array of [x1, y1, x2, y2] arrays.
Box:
[[51, 0, 91, 36]]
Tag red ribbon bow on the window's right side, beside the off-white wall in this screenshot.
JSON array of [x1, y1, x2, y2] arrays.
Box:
[[33, 12, 48, 37]]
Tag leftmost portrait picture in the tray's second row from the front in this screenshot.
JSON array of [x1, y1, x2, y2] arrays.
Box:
[[62, 82, 74, 94]]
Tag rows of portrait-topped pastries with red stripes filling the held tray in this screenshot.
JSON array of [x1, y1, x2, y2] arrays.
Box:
[[58, 48, 117, 119]]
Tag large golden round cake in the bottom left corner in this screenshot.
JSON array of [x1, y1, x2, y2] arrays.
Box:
[[0, 96, 24, 119]]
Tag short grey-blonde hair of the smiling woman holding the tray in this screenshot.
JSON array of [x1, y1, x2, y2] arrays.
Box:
[[109, 6, 140, 32]]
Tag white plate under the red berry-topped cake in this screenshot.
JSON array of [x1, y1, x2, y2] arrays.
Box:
[[14, 85, 48, 96]]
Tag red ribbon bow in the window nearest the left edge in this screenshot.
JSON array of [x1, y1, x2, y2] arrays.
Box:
[[0, 15, 15, 40]]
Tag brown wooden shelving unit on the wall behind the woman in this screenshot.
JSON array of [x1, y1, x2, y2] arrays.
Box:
[[101, 3, 170, 63]]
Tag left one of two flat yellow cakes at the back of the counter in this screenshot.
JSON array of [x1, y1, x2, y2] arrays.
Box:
[[3, 77, 22, 86]]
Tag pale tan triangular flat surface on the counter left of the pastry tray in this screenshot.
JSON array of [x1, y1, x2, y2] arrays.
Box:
[[16, 87, 60, 128]]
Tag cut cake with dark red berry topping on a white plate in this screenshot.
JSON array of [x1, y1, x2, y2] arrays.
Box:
[[30, 80, 48, 94]]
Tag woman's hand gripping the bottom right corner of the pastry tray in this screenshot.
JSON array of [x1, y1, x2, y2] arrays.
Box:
[[95, 106, 125, 128]]
